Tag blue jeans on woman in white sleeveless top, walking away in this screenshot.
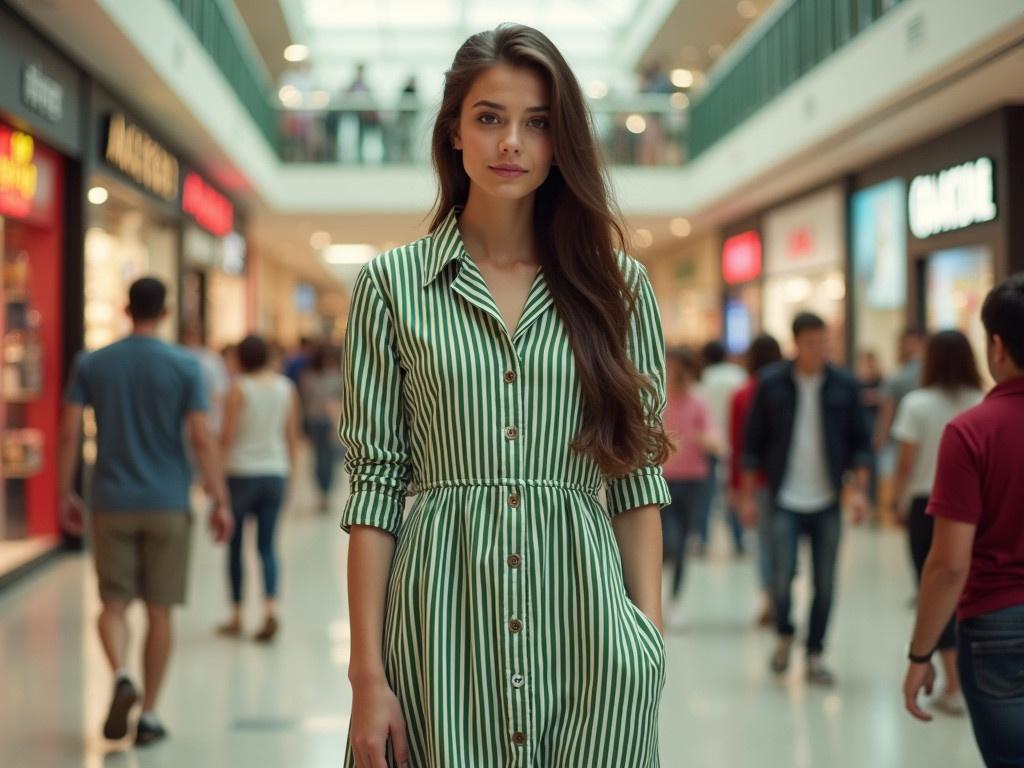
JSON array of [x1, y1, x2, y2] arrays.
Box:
[[227, 475, 286, 604]]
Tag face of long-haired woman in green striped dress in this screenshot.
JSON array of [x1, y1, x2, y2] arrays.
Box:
[[452, 65, 554, 200]]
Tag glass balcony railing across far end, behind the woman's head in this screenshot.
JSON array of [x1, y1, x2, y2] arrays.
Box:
[[279, 92, 688, 166]]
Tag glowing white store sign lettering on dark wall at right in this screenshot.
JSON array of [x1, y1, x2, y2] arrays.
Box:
[[907, 158, 996, 240]]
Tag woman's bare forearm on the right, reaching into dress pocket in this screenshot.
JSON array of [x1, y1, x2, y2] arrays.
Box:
[[611, 505, 662, 629]]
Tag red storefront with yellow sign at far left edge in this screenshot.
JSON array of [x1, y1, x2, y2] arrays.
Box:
[[0, 8, 82, 581]]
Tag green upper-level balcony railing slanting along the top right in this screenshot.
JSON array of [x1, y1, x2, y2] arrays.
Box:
[[689, 0, 901, 158]]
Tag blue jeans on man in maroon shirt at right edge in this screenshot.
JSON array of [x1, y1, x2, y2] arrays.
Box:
[[956, 605, 1024, 768]]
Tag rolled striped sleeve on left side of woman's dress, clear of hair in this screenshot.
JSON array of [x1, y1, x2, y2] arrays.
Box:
[[338, 263, 411, 536]]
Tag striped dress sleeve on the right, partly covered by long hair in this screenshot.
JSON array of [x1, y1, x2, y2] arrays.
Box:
[[605, 260, 671, 516]]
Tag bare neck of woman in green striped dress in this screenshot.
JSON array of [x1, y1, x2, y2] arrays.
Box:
[[459, 189, 537, 266]]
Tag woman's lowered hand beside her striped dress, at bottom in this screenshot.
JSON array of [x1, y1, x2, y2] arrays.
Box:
[[349, 678, 409, 768]]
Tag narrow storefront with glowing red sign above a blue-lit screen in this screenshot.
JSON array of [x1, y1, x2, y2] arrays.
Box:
[[721, 221, 764, 356]]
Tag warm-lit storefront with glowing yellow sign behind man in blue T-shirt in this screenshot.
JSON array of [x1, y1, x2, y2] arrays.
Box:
[[84, 87, 182, 349]]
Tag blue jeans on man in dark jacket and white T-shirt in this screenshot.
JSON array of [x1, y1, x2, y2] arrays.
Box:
[[770, 505, 842, 653]]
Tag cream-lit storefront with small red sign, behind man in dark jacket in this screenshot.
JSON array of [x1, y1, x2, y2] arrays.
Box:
[[762, 184, 848, 364]]
